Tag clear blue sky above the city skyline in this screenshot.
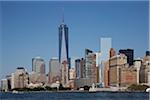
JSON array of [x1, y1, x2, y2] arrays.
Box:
[[0, 1, 149, 79]]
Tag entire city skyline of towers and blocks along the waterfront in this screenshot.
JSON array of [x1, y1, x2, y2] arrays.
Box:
[[1, 17, 150, 91]]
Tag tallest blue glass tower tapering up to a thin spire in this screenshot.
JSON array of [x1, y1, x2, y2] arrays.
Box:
[[59, 11, 70, 69]]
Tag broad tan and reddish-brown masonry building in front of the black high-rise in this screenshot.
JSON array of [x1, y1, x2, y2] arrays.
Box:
[[109, 54, 137, 87]]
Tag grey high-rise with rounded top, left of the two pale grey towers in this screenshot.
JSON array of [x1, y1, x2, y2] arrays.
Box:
[[32, 57, 45, 74]]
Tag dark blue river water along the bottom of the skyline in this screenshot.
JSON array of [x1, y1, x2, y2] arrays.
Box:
[[0, 92, 150, 100]]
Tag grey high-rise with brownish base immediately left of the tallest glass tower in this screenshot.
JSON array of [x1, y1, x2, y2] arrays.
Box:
[[49, 58, 61, 83]]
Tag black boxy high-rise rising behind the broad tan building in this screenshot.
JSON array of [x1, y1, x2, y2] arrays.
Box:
[[119, 49, 134, 65]]
